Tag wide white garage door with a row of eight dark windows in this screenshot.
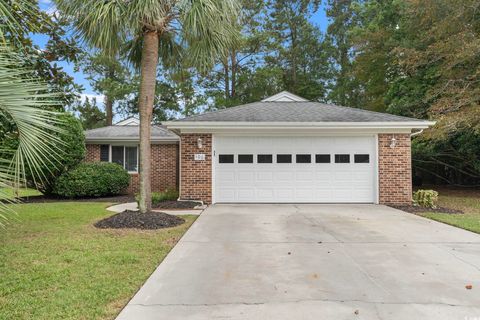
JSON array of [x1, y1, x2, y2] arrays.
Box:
[[214, 135, 376, 203]]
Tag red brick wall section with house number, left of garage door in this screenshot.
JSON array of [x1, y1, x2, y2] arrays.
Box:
[[180, 134, 212, 204]]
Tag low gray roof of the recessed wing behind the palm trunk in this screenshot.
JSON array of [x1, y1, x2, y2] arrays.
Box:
[[85, 125, 178, 141]]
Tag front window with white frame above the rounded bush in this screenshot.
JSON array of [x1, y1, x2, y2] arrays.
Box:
[[100, 145, 138, 172]]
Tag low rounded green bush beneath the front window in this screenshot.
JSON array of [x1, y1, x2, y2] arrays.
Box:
[[52, 162, 130, 198]]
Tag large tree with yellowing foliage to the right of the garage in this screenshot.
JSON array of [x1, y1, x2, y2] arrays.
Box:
[[328, 0, 480, 185]]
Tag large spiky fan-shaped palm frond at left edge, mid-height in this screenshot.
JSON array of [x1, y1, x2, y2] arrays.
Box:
[[0, 48, 63, 225]]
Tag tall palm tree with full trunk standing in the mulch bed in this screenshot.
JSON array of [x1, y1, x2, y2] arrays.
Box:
[[56, 0, 240, 213]]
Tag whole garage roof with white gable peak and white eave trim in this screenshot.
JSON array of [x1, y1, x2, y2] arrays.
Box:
[[164, 91, 435, 129]]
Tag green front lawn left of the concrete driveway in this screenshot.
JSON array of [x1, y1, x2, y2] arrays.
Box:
[[0, 202, 196, 320]]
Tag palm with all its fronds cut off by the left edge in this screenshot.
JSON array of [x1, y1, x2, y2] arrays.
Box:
[[0, 0, 63, 227]]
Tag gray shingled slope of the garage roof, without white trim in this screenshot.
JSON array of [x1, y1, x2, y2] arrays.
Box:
[[176, 101, 423, 122]]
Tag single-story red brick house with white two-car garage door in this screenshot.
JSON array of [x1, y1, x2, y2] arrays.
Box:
[[86, 91, 434, 204]]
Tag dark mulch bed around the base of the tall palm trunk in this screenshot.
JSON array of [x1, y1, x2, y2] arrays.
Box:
[[95, 210, 185, 230]]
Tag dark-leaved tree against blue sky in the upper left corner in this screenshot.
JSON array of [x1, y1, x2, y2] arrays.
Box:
[[0, 0, 83, 111]]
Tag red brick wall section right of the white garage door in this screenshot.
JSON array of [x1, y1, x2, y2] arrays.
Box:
[[378, 133, 412, 204]]
